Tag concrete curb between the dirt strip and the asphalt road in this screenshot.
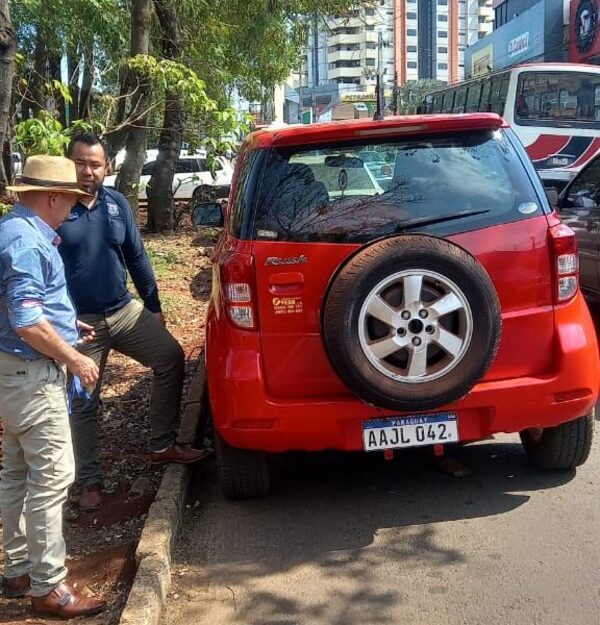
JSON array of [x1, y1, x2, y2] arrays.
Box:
[[119, 357, 204, 625]]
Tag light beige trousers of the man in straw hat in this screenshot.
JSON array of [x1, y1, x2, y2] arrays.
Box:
[[0, 354, 75, 597]]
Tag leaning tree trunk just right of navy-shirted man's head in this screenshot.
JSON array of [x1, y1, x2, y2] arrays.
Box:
[[117, 0, 152, 216]]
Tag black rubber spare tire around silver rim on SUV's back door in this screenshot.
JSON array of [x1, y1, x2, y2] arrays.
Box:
[[323, 235, 502, 412]]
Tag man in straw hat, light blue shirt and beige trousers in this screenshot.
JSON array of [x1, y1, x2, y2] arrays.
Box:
[[0, 156, 106, 618]]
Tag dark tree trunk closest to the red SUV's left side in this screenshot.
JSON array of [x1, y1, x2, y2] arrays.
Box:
[[147, 0, 185, 232]]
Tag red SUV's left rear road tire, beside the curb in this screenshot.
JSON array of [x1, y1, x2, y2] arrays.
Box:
[[215, 433, 271, 499]]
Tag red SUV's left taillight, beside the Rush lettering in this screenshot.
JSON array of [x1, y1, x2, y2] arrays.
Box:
[[221, 252, 257, 330]]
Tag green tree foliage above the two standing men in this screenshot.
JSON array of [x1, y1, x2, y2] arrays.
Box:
[[8, 0, 373, 227]]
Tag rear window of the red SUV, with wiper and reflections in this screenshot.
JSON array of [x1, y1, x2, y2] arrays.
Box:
[[253, 131, 542, 242]]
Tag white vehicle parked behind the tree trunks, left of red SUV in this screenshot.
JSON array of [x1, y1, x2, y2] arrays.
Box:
[[104, 156, 233, 201]]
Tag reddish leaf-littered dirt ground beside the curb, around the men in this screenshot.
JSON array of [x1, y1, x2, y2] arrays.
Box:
[[0, 222, 214, 625]]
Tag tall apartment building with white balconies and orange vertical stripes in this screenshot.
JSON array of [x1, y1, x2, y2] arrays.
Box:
[[300, 0, 494, 93]]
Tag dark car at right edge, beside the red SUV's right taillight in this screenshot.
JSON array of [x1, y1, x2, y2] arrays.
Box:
[[551, 154, 600, 295]]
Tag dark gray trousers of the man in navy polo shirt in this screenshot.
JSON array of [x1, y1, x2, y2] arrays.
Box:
[[71, 300, 185, 485]]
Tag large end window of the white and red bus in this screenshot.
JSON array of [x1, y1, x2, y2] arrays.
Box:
[[515, 72, 600, 128]]
